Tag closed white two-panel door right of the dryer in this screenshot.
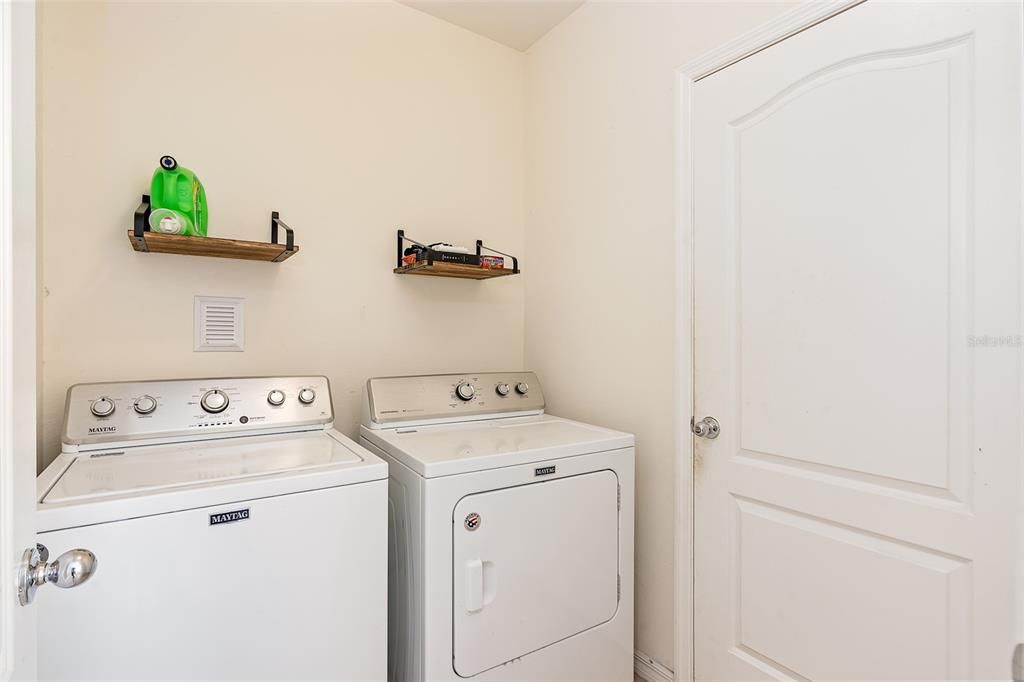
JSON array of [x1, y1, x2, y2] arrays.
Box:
[[691, 0, 1022, 680]]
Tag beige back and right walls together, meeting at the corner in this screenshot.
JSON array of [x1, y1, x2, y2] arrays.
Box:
[[39, 1, 787, 667]]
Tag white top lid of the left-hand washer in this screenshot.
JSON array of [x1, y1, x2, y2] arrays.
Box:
[[46, 431, 365, 505]]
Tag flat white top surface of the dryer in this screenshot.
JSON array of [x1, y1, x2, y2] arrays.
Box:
[[360, 415, 634, 478]]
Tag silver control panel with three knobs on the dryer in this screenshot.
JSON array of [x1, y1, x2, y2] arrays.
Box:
[[367, 372, 544, 426]]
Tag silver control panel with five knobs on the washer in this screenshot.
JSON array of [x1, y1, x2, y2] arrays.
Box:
[[61, 377, 334, 445]]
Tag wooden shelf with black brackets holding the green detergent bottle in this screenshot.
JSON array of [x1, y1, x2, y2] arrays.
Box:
[[128, 195, 299, 263]]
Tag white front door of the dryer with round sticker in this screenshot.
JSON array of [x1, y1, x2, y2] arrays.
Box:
[[453, 471, 618, 677]]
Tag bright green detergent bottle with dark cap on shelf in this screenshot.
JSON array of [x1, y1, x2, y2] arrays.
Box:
[[150, 157, 210, 237]]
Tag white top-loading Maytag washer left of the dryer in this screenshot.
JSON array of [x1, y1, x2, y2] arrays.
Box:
[[35, 377, 387, 681]]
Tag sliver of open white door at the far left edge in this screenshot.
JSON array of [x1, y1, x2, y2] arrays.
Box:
[[0, 2, 36, 680]]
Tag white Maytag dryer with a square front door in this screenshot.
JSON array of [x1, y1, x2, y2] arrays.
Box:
[[360, 372, 634, 682]]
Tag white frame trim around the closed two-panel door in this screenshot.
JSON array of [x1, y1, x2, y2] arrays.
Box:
[[673, 0, 867, 680]]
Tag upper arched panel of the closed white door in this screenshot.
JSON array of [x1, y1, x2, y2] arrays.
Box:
[[730, 39, 971, 496]]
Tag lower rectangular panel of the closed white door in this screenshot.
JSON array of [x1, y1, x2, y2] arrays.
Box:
[[734, 498, 971, 680]]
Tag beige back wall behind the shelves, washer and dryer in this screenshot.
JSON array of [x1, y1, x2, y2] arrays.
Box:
[[38, 2, 525, 465]]
